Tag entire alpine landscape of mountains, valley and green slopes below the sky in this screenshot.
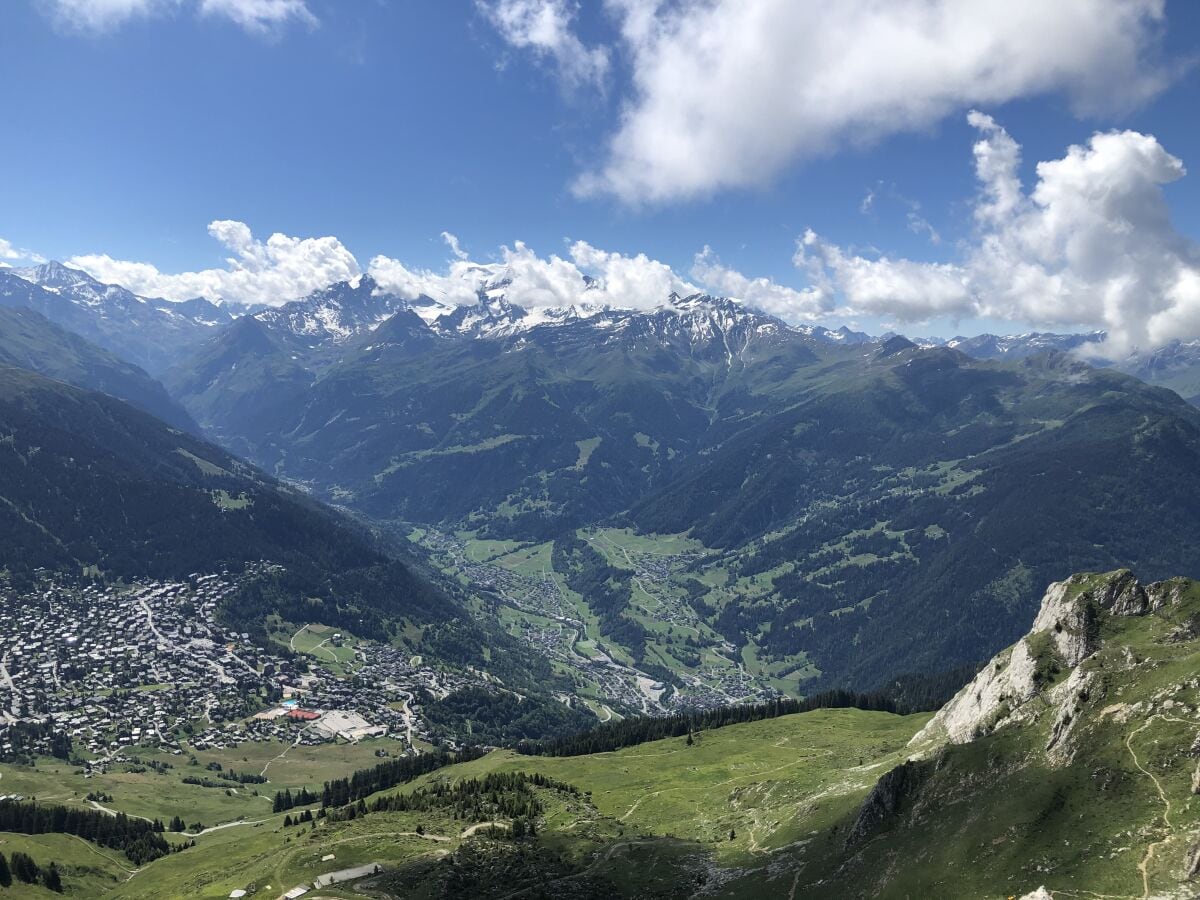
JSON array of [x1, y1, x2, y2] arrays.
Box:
[[0, 263, 1200, 900]]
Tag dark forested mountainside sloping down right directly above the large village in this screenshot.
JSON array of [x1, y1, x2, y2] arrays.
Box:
[[0, 368, 454, 631]]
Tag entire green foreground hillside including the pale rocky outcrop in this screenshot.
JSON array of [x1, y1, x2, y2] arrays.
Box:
[[4, 571, 1185, 900]]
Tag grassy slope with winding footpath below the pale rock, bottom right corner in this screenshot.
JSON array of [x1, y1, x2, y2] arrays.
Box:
[[763, 582, 1200, 898]]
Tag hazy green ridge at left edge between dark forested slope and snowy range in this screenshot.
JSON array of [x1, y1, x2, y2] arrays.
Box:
[[0, 307, 199, 433]]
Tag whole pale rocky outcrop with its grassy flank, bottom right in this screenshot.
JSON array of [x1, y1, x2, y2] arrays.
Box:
[[822, 570, 1200, 900]]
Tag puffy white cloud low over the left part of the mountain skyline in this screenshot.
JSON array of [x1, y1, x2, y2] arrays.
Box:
[[66, 220, 361, 305]]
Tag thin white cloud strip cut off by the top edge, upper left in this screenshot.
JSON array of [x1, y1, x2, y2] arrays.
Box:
[[42, 0, 317, 37]]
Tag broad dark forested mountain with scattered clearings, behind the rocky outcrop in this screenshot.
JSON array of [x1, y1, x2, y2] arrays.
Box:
[[629, 344, 1200, 686]]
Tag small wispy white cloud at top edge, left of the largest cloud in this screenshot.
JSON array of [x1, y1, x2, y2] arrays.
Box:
[[476, 0, 608, 89]]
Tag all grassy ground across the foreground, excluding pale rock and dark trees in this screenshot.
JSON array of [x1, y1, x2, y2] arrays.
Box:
[[9, 582, 1200, 900]]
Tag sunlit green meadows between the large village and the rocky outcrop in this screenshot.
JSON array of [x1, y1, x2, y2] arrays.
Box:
[[4, 709, 928, 898]]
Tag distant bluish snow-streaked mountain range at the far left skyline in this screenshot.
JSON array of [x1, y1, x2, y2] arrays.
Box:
[[0, 263, 232, 374]]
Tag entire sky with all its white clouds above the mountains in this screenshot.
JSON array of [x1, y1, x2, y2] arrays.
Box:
[[0, 0, 1200, 348]]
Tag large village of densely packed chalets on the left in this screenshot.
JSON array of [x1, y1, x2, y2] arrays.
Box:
[[0, 566, 475, 768]]
